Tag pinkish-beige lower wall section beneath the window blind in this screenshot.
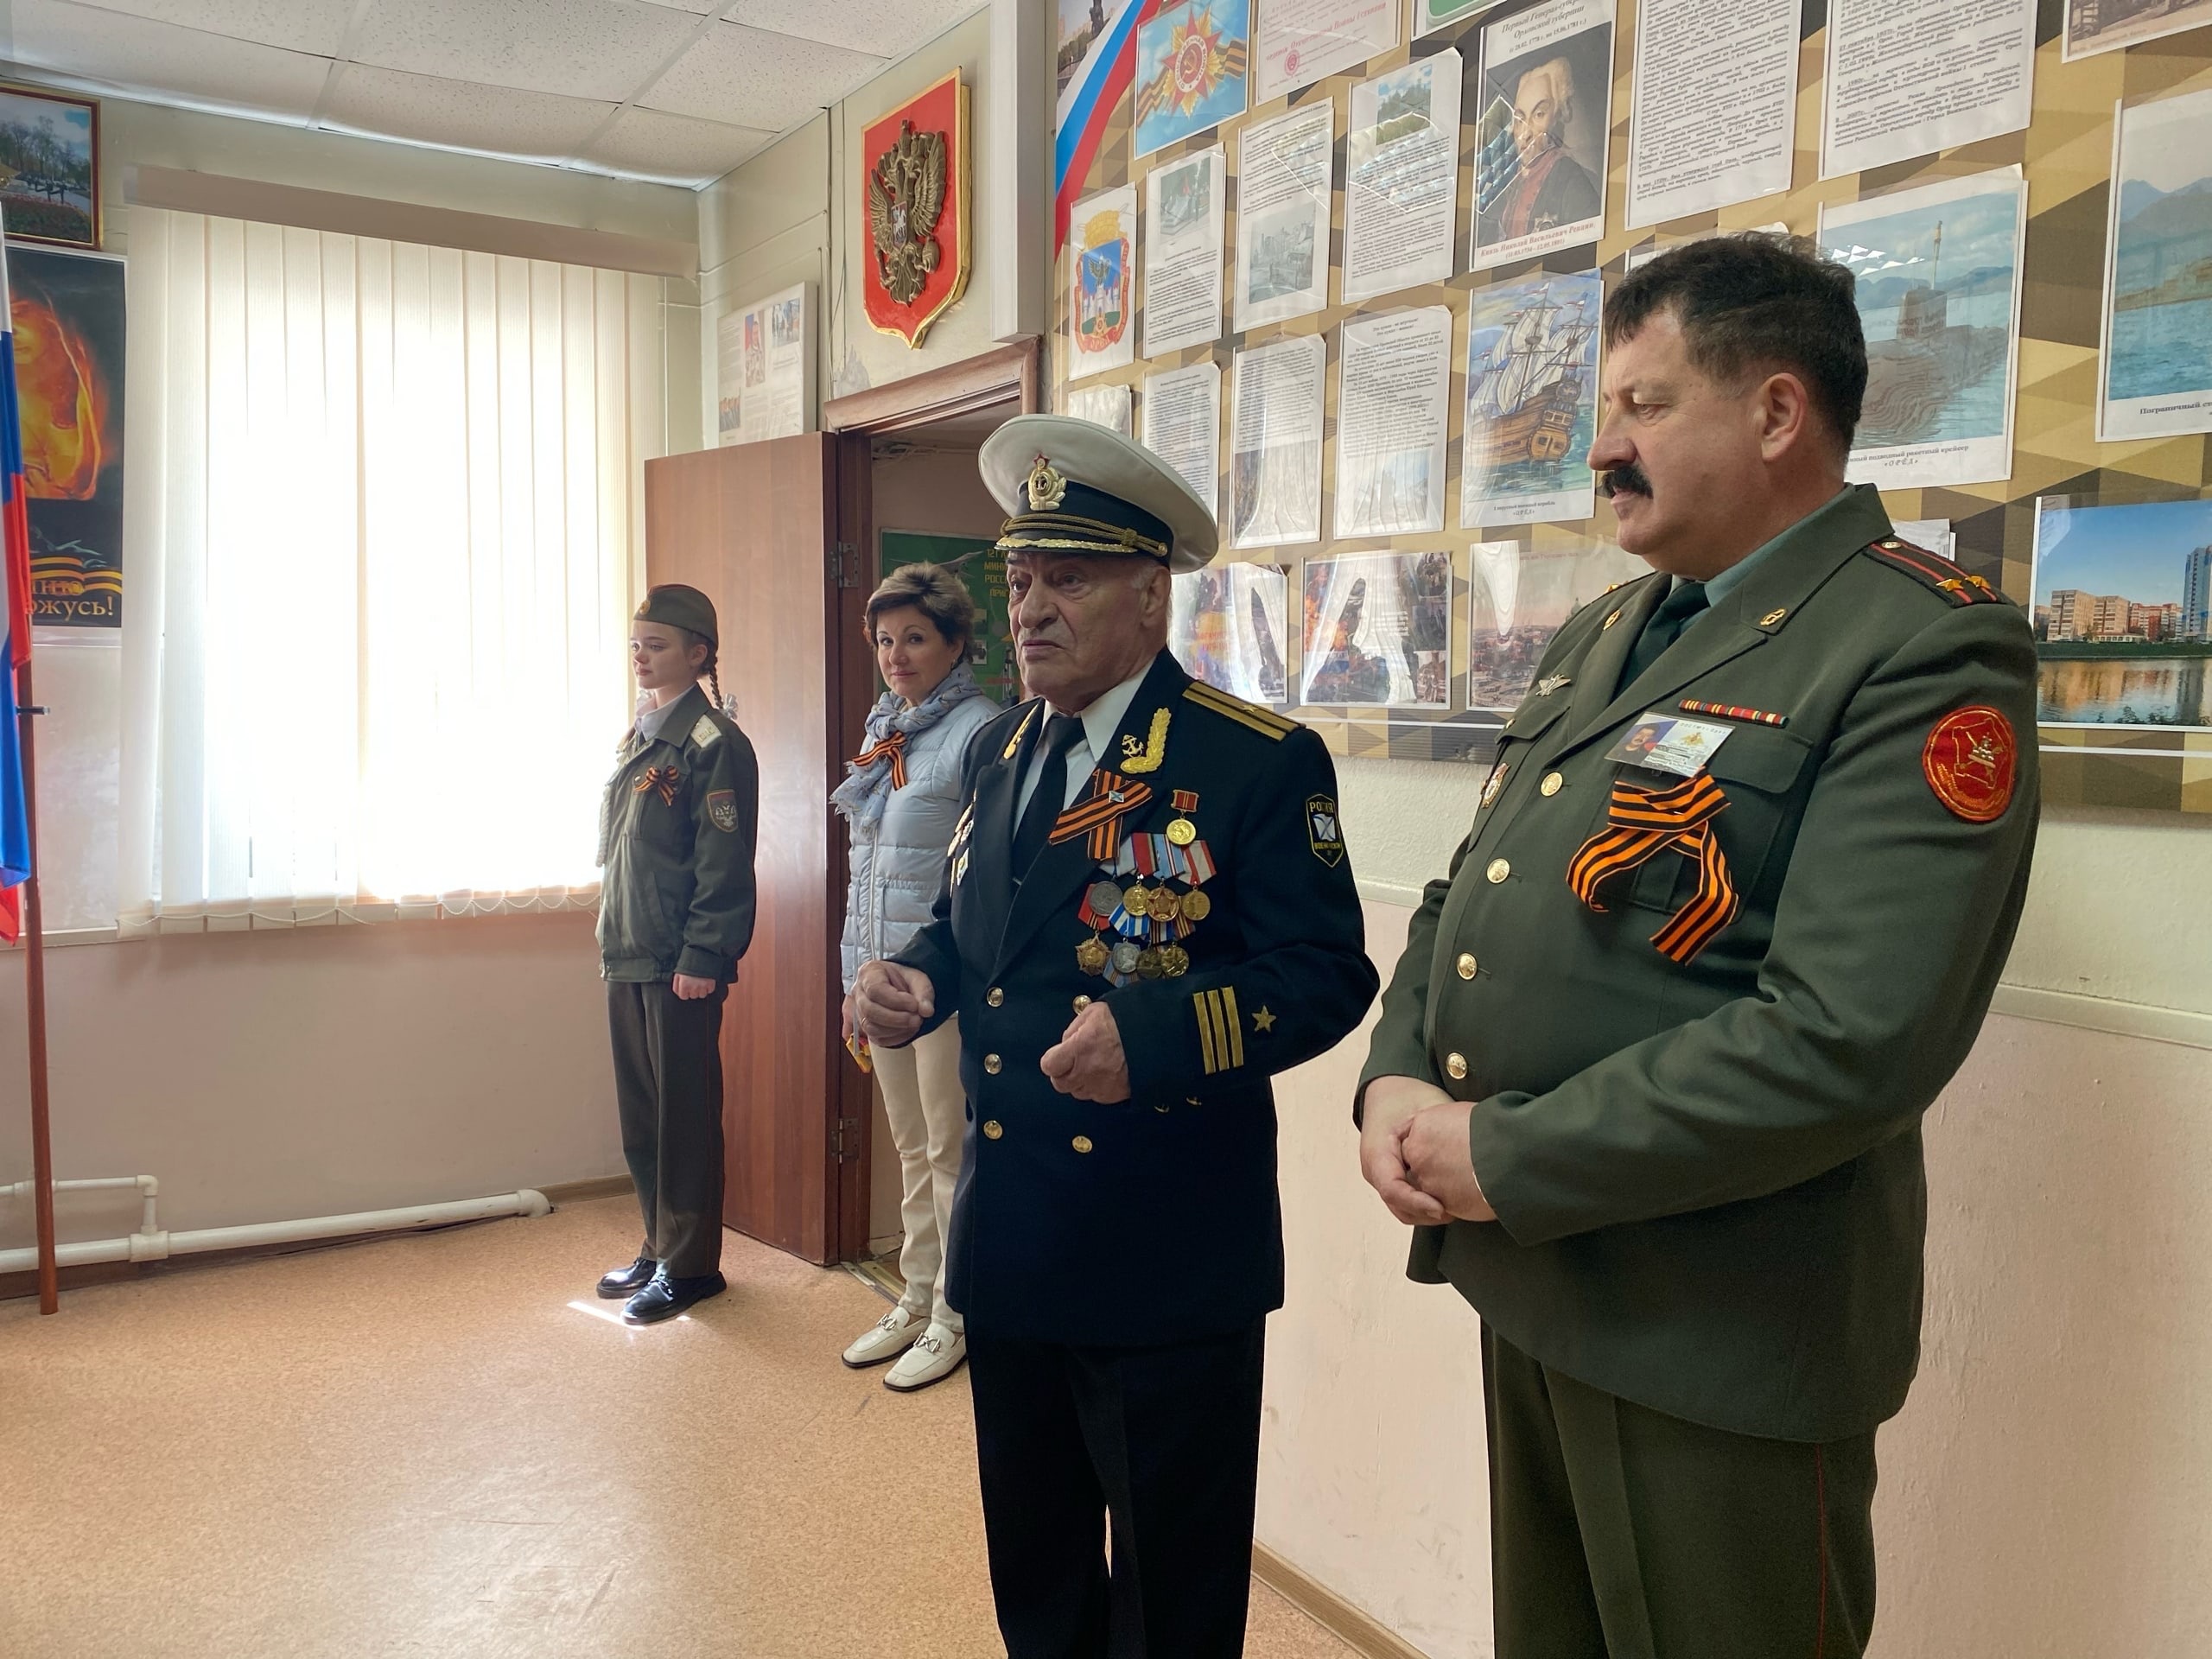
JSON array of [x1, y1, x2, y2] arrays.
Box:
[[0, 912, 621, 1256]]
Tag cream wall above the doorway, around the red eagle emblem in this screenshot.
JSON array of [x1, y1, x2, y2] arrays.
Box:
[[699, 11, 995, 448]]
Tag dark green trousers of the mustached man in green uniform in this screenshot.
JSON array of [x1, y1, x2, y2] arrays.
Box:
[[1482, 1325, 1873, 1659]]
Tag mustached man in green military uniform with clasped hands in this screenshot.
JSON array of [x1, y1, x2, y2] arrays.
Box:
[[1360, 237, 2037, 1659]]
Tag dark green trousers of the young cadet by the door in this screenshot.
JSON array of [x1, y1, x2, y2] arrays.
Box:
[[606, 980, 730, 1279]]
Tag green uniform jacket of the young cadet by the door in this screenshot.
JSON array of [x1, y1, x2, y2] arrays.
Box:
[[600, 686, 761, 982]]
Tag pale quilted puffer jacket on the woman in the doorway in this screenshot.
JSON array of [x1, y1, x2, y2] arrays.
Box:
[[842, 692, 1002, 991]]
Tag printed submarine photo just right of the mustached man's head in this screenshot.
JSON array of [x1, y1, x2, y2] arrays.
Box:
[[1822, 168, 2024, 489]]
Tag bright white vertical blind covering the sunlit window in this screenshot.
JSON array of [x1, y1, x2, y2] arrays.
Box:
[[119, 208, 664, 936]]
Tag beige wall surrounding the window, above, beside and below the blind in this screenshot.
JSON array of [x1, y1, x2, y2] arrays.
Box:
[[0, 99, 699, 1238]]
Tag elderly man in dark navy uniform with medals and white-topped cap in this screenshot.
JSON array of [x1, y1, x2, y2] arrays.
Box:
[[854, 416, 1376, 1659]]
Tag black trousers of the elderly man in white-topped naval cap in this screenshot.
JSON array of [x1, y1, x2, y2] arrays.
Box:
[[969, 1320, 1268, 1659]]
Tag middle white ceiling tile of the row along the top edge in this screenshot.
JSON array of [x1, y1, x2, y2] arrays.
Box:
[[354, 0, 699, 104]]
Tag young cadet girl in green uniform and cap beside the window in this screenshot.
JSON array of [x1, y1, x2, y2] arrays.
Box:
[[600, 584, 761, 1325]]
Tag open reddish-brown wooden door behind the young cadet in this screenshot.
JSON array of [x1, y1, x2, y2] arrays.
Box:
[[646, 434, 868, 1263]]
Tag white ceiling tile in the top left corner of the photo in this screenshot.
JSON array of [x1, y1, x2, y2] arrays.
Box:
[[13, 0, 329, 119]]
